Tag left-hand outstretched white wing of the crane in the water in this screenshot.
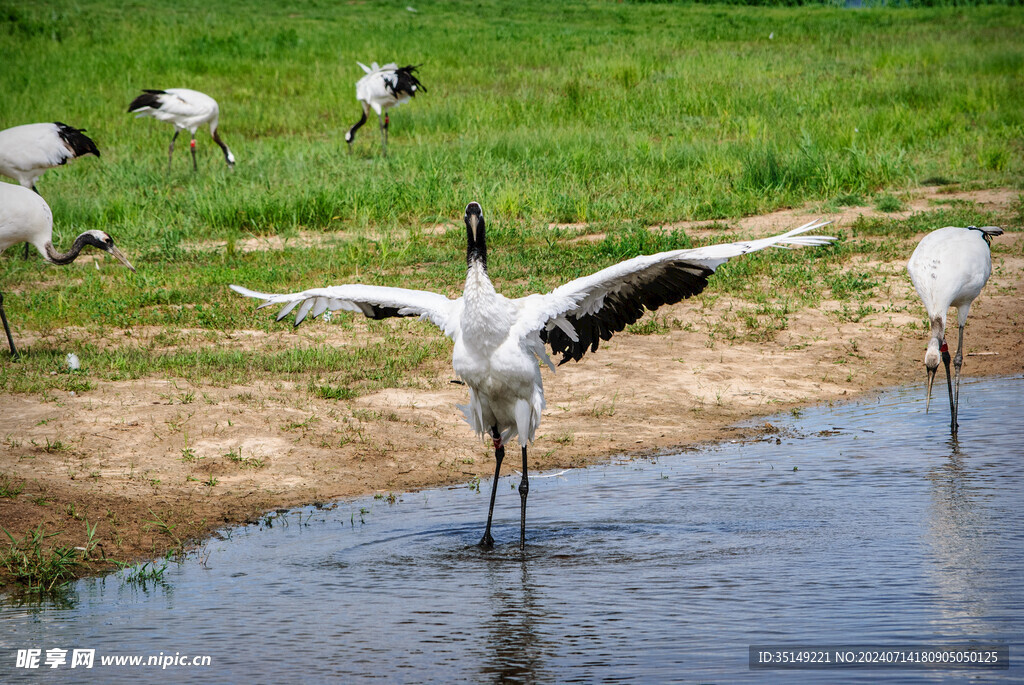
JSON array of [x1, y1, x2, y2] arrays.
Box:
[[230, 284, 460, 337]]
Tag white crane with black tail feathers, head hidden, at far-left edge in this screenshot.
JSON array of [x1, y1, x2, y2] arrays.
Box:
[[0, 121, 99, 259]]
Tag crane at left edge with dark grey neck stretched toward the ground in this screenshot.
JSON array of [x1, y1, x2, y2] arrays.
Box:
[[0, 183, 135, 358]]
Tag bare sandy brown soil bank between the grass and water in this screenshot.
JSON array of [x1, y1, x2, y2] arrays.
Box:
[[0, 185, 1024, 589]]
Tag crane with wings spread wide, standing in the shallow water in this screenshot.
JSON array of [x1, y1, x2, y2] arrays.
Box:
[[231, 202, 835, 549]]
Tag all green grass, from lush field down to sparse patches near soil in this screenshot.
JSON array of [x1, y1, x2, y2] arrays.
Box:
[[0, 0, 1024, 399]]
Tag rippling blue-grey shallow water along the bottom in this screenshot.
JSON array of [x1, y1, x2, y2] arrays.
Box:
[[0, 378, 1024, 683]]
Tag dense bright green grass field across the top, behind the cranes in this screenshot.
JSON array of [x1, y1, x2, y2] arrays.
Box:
[[0, 0, 1024, 245]]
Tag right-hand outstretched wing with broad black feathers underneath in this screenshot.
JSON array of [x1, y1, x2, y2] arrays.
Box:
[[513, 221, 836, 363]]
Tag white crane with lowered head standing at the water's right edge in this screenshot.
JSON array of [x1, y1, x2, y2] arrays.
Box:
[[906, 226, 1002, 439]]
